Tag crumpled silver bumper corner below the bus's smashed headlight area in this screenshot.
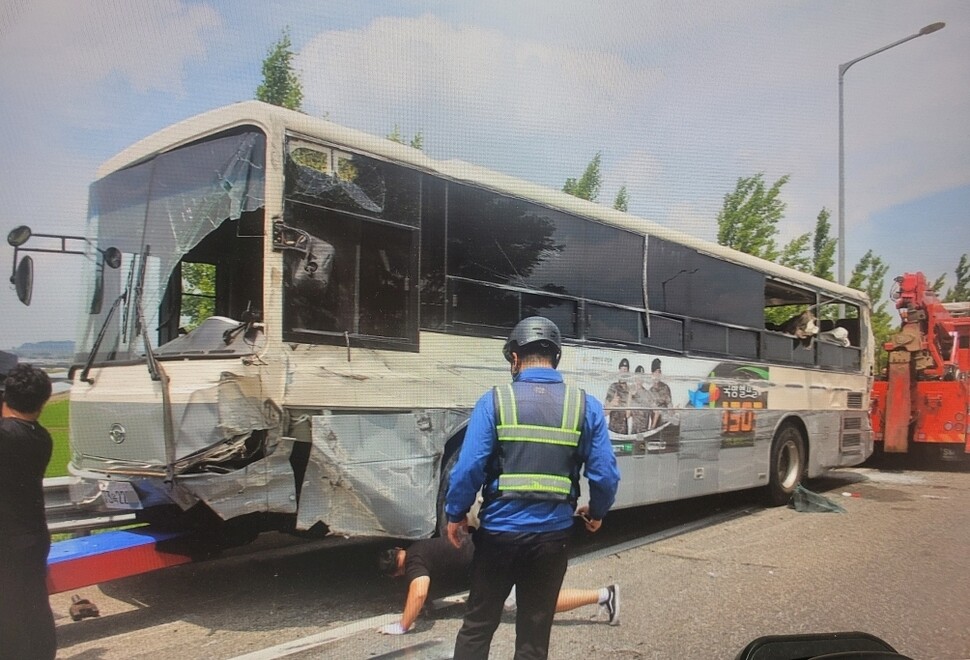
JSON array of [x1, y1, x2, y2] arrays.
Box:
[[176, 438, 296, 520]]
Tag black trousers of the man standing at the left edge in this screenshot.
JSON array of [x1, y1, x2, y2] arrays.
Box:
[[0, 533, 57, 660]]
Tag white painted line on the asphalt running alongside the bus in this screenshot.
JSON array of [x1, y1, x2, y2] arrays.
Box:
[[231, 507, 756, 660]]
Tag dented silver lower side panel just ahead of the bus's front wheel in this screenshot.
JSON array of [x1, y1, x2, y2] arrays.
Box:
[[297, 410, 468, 539]]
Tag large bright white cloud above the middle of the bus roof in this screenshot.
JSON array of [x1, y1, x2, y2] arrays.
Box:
[[298, 16, 661, 153]]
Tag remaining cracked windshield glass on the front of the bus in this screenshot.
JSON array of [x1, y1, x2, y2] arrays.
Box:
[[76, 127, 266, 362]]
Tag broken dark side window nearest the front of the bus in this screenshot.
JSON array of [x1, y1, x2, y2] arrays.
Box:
[[283, 138, 421, 347]]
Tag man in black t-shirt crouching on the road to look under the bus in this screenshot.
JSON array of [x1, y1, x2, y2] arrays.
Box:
[[377, 536, 620, 635]]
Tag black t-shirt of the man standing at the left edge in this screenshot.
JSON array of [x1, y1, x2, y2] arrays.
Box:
[[0, 417, 54, 536]]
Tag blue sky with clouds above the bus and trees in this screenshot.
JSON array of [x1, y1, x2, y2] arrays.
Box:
[[0, 0, 970, 348]]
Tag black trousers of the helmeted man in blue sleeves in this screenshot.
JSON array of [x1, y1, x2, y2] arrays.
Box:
[[454, 529, 570, 660]]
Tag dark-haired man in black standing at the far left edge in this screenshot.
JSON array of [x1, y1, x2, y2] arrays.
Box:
[[0, 364, 57, 660]]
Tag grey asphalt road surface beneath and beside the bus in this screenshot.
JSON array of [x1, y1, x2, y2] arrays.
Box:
[[51, 468, 970, 660]]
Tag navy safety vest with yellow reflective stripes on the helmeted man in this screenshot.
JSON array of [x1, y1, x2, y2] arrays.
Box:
[[486, 381, 586, 503]]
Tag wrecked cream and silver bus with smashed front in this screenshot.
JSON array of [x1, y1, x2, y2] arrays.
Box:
[[9, 101, 873, 538]]
